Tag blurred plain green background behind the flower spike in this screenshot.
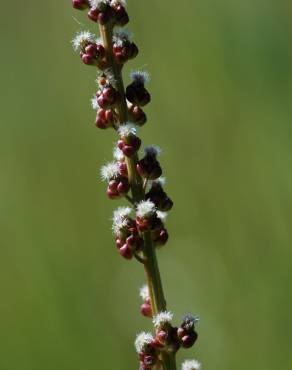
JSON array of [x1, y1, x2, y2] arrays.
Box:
[[0, 0, 292, 370]]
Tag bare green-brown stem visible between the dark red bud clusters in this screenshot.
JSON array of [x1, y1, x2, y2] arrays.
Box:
[[99, 24, 176, 370]]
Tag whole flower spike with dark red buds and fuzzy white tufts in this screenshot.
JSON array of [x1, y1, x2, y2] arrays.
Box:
[[72, 0, 200, 370]]
